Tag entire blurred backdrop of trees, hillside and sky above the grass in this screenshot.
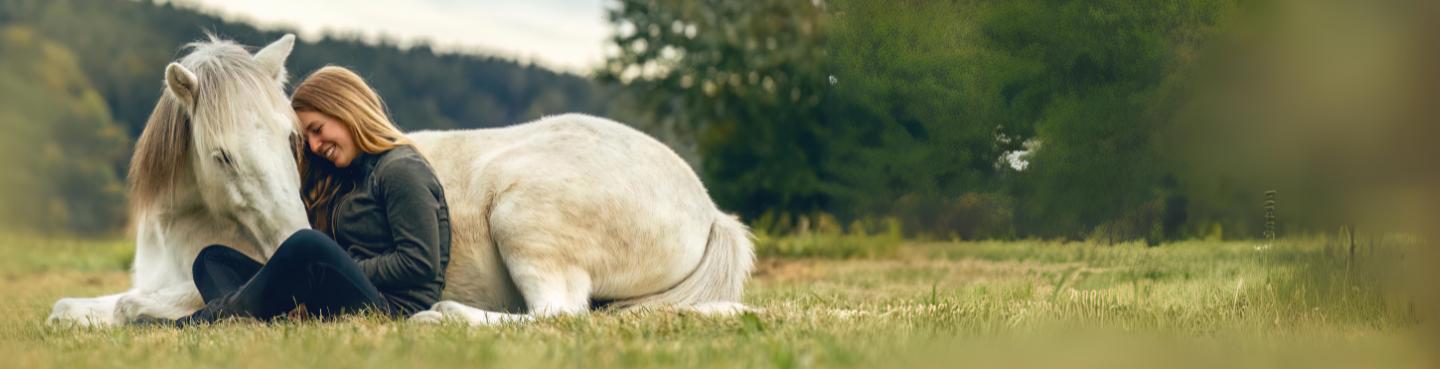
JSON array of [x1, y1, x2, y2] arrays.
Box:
[[0, 0, 1440, 245]]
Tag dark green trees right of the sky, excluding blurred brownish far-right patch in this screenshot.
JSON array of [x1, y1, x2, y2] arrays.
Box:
[[602, 0, 1234, 241]]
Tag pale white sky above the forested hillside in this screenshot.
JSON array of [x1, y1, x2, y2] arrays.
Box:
[[174, 0, 613, 74]]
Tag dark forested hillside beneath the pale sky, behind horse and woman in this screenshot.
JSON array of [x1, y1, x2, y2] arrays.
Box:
[[0, 0, 608, 137]]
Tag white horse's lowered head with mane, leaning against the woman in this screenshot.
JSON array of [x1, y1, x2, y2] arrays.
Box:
[[130, 35, 310, 258]]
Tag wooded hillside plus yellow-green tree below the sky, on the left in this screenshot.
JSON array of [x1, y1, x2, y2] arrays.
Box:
[[0, 0, 622, 234]]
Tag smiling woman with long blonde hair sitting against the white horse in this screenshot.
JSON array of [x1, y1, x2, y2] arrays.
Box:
[[179, 66, 451, 324]]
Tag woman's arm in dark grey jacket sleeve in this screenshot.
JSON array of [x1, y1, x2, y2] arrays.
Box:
[[359, 157, 444, 288]]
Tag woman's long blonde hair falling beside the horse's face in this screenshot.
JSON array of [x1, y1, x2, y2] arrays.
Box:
[[289, 65, 410, 231]]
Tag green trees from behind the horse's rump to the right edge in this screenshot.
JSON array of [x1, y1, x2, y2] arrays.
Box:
[[598, 0, 1437, 245]]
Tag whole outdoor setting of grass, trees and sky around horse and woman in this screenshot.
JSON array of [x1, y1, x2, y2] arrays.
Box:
[[0, 0, 1440, 368]]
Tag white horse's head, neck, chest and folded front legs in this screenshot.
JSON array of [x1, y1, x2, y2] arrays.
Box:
[[49, 36, 310, 326]]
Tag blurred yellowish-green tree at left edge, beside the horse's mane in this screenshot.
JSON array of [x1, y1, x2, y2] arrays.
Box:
[[0, 26, 127, 234]]
